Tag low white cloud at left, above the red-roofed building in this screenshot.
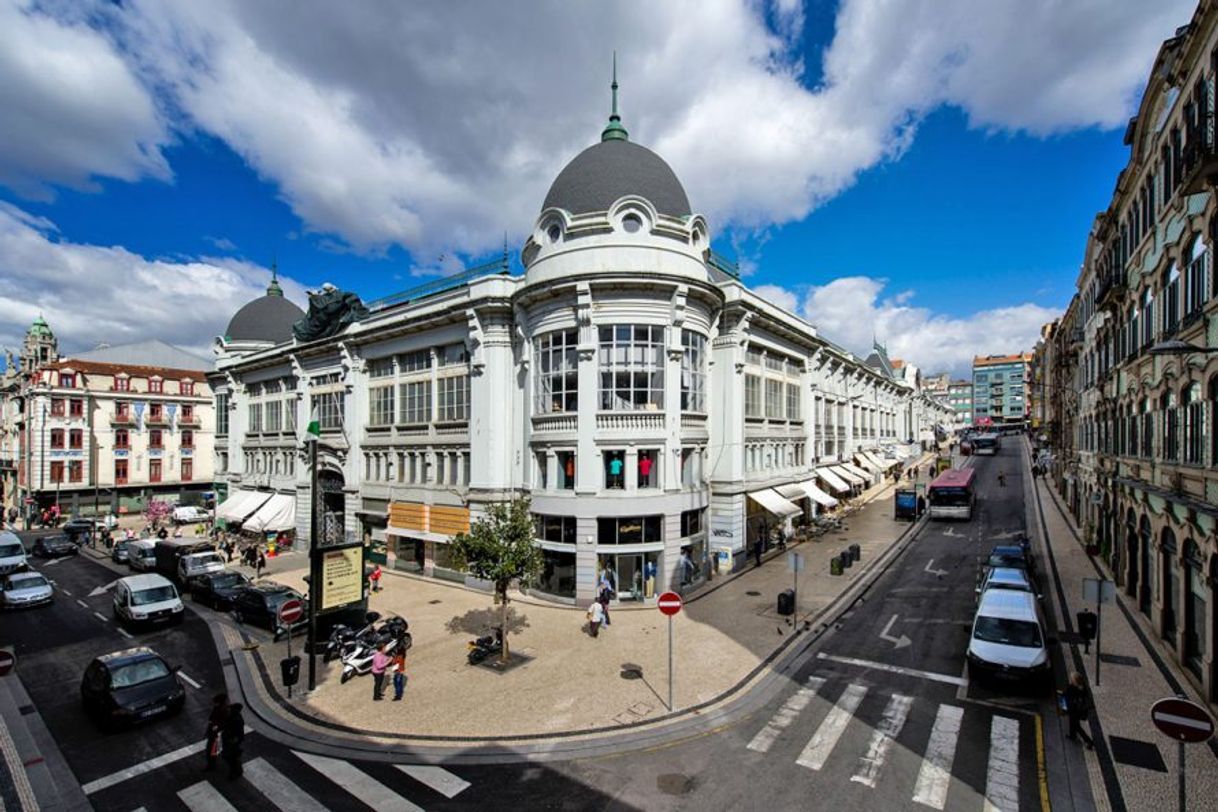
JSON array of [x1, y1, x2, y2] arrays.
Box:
[[0, 206, 307, 358]]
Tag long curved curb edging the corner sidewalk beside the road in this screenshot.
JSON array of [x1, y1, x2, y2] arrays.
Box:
[[209, 496, 928, 763]]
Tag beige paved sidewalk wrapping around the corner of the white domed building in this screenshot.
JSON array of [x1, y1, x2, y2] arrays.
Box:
[[239, 460, 929, 744]]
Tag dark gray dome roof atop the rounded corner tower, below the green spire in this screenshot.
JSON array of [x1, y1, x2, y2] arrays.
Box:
[[542, 139, 691, 217]]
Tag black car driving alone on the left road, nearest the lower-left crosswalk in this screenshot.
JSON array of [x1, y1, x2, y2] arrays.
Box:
[[80, 646, 186, 727]]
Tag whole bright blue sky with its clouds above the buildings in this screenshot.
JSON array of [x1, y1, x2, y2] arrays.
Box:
[[0, 0, 1191, 371]]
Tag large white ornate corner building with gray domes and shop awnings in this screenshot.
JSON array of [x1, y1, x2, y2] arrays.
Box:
[[212, 91, 950, 600]]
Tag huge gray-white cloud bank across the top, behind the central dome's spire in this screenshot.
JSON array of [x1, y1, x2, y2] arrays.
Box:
[[0, 0, 1179, 256]]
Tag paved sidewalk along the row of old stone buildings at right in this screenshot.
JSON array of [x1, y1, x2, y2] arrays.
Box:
[[1030, 450, 1218, 811]]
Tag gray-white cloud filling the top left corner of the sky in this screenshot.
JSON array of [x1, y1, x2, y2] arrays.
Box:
[[0, 0, 171, 197]]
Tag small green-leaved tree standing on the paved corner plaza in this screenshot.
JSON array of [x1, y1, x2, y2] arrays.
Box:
[[449, 499, 543, 662]]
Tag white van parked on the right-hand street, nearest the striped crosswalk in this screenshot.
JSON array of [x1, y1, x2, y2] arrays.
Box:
[[968, 589, 1052, 689]]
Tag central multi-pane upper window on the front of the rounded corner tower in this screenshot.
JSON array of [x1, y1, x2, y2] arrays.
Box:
[[599, 324, 664, 411]]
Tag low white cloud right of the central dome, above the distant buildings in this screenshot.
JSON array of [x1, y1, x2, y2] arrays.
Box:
[[799, 276, 1058, 374]]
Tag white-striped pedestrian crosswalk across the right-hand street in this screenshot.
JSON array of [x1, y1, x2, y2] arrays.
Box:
[[747, 676, 1032, 812]]
